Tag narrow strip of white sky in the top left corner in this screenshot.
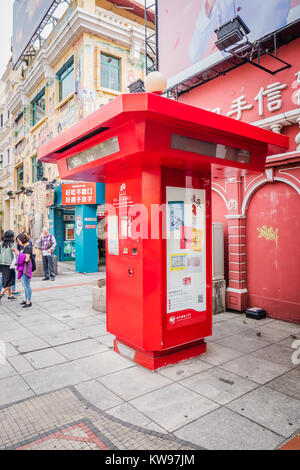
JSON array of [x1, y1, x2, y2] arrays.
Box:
[[0, 0, 13, 77]]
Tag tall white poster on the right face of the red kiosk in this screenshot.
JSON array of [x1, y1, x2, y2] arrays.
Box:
[[166, 186, 206, 326]]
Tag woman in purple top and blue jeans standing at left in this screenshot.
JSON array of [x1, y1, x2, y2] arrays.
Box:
[[16, 233, 32, 308]]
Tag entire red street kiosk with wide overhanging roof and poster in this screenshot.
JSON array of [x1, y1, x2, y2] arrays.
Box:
[[38, 93, 288, 369]]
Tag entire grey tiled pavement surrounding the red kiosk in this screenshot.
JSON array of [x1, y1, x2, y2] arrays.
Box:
[[0, 273, 300, 449]]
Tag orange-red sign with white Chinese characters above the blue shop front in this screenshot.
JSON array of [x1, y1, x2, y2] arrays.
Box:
[[62, 183, 96, 206]]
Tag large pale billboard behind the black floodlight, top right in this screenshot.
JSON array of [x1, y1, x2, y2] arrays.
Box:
[[158, 0, 300, 88]]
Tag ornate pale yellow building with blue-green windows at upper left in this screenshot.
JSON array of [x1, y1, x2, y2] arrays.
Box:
[[0, 0, 151, 241]]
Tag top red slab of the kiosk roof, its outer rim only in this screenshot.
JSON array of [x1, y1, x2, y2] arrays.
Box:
[[38, 93, 289, 163]]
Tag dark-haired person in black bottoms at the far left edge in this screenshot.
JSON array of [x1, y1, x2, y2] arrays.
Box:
[[0, 230, 16, 301]]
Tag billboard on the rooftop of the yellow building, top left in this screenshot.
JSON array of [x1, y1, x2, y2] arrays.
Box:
[[12, 0, 54, 65]]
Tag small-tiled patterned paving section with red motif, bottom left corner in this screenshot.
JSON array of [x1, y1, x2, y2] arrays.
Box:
[[0, 387, 202, 450]]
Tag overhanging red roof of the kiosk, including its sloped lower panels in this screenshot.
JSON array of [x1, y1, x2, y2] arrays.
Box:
[[37, 93, 289, 181]]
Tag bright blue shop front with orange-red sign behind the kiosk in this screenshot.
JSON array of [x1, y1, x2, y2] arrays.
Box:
[[47, 182, 105, 273]]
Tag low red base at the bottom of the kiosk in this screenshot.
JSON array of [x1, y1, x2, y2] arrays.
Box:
[[114, 338, 206, 370]]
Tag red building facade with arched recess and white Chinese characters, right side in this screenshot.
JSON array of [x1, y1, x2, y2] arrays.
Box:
[[179, 39, 300, 323]]
